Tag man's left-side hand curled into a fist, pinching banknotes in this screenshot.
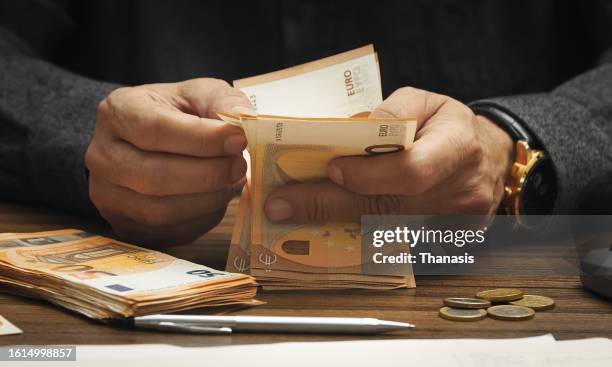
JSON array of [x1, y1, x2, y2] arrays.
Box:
[[85, 79, 253, 249]]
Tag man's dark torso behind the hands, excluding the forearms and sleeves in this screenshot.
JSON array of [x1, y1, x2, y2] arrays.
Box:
[[0, 0, 612, 101]]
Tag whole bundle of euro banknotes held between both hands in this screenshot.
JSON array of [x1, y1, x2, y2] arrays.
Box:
[[226, 45, 416, 290]]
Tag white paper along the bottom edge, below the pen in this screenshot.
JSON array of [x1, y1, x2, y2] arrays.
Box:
[[19, 334, 612, 367]]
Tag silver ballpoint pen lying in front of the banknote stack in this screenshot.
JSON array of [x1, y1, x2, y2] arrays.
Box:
[[116, 315, 414, 334]]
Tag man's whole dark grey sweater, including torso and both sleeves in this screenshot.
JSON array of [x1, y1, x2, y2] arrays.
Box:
[[0, 0, 612, 214]]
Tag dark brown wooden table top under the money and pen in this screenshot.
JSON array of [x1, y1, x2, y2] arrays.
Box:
[[0, 203, 612, 346]]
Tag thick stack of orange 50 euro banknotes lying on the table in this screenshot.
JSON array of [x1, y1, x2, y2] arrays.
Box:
[[0, 229, 258, 319]]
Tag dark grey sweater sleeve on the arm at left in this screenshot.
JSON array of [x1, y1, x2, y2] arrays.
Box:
[[0, 0, 117, 213]]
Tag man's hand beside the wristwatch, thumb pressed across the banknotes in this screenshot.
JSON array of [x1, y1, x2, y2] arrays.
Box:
[[265, 88, 513, 223]]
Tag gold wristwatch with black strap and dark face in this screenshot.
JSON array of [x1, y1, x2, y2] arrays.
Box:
[[469, 101, 557, 228]]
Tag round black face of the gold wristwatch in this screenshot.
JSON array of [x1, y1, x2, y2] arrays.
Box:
[[520, 159, 557, 223]]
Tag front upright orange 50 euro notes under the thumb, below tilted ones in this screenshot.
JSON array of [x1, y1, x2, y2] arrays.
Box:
[[222, 115, 416, 288]]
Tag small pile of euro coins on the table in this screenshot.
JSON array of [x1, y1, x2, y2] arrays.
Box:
[[440, 288, 555, 321]]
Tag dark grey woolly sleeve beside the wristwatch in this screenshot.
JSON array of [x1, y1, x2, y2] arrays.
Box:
[[474, 48, 612, 214]]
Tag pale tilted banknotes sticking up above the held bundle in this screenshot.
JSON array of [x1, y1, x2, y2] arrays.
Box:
[[233, 45, 382, 152]]
